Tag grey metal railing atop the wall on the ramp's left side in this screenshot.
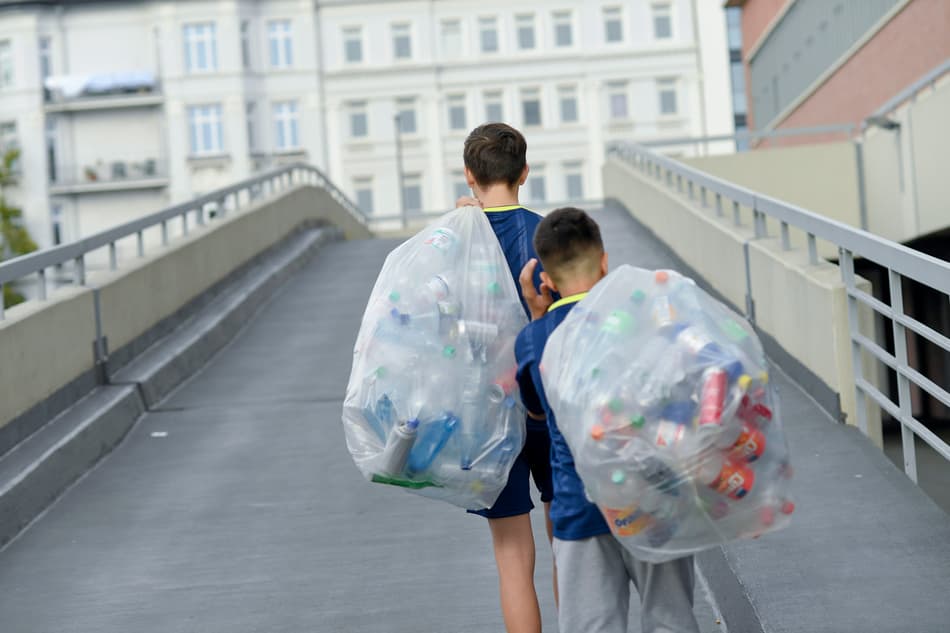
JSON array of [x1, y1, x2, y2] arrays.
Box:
[[0, 163, 367, 321]]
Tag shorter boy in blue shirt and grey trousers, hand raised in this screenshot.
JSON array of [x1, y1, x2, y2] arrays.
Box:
[[515, 208, 699, 633]]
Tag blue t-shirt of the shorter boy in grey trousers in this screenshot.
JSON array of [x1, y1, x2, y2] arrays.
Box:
[[515, 295, 610, 541]]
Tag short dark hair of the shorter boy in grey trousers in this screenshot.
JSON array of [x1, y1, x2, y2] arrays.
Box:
[[534, 207, 604, 281]]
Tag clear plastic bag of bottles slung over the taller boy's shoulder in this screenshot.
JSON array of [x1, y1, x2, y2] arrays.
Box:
[[343, 207, 527, 510]]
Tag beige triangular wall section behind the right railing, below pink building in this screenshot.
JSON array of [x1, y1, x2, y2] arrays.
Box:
[[681, 141, 861, 258]]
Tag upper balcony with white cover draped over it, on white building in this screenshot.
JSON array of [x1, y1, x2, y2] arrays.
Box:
[[43, 71, 164, 113]]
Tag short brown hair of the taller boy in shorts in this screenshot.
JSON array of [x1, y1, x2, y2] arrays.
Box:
[[462, 123, 528, 187]]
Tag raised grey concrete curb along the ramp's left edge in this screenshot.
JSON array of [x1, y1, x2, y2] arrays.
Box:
[[0, 227, 342, 548]]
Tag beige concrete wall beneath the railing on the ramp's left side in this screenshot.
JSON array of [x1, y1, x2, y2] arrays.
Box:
[[0, 187, 369, 427]]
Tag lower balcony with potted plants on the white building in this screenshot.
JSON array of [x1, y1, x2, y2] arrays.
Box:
[[50, 158, 168, 195]]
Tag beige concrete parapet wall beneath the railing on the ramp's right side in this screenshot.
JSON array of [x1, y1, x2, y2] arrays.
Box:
[[604, 159, 881, 445]]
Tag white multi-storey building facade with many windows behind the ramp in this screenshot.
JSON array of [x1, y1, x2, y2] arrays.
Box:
[[0, 0, 732, 252]]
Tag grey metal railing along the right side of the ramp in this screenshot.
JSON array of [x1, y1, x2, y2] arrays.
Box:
[[607, 143, 950, 482]]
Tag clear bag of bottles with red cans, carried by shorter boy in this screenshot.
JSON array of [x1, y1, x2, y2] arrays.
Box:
[[541, 266, 795, 562]]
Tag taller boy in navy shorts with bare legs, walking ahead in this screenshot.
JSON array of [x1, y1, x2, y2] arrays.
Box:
[[456, 123, 557, 633]]
